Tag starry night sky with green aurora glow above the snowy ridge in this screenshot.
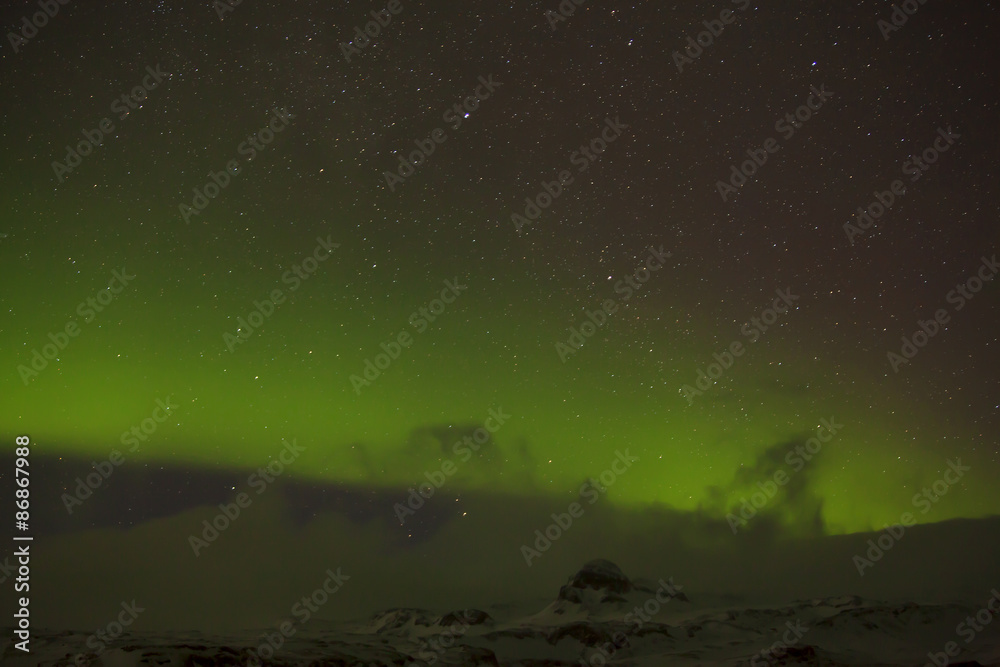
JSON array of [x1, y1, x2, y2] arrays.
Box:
[[0, 0, 1000, 627]]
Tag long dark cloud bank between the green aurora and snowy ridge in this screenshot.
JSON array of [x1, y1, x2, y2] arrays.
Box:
[[0, 446, 1000, 630]]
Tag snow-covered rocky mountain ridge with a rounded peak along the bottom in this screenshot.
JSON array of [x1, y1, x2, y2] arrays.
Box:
[[2, 560, 1000, 667]]
